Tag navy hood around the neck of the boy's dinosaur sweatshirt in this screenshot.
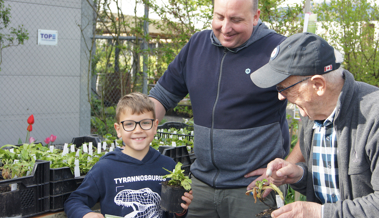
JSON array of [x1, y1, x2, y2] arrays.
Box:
[[100, 147, 160, 165]]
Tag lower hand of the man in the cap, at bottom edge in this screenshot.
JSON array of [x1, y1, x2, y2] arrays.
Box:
[[271, 201, 322, 218]]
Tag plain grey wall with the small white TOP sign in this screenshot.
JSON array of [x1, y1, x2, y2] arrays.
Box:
[[0, 0, 93, 146]]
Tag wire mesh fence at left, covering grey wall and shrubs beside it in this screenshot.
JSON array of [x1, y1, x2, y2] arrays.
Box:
[[0, 0, 164, 146]]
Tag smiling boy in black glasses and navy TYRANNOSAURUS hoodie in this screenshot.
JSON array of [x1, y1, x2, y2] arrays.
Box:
[[64, 93, 192, 218]]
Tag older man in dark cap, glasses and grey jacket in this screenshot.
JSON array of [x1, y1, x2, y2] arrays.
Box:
[[251, 33, 379, 218]]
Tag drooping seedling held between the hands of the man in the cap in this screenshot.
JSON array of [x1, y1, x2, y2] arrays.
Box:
[[246, 179, 284, 218]]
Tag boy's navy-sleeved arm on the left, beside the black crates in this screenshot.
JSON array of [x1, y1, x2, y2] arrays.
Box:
[[64, 174, 102, 217]]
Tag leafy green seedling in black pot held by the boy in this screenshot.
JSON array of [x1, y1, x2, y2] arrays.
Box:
[[161, 162, 192, 213]]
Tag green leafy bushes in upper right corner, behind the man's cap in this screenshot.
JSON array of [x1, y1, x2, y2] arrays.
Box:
[[313, 0, 379, 86]]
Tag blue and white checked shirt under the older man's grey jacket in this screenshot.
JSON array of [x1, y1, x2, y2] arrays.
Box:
[[312, 110, 340, 204]]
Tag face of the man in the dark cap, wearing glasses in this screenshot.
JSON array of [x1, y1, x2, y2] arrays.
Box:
[[277, 76, 318, 120]]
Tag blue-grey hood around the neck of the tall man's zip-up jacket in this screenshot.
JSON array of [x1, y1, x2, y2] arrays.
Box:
[[210, 19, 276, 53]]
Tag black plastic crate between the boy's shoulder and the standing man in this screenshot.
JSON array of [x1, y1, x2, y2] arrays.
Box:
[[162, 146, 192, 175]]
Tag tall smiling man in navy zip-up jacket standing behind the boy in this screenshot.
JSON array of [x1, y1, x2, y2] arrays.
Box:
[[150, 0, 296, 218]]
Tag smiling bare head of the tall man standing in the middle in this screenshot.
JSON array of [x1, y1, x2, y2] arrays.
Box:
[[212, 0, 260, 48]]
